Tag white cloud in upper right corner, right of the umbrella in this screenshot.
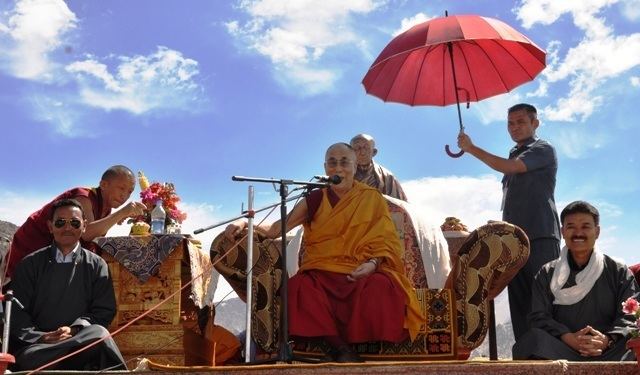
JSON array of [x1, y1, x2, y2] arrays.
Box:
[[515, 0, 640, 122]]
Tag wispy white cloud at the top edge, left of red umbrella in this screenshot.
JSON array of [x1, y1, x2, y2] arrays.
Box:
[[226, 0, 384, 94]]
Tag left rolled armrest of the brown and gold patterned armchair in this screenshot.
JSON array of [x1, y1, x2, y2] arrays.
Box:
[[210, 231, 282, 353]]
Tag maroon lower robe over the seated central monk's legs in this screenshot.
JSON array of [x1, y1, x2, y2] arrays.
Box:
[[288, 270, 408, 343]]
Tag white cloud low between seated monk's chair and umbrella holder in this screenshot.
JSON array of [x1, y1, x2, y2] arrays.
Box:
[[402, 175, 502, 230]]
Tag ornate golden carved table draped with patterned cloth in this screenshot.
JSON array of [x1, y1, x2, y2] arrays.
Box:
[[94, 234, 211, 365]]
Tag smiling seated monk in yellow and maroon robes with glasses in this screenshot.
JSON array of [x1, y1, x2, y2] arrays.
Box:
[[225, 143, 425, 362]]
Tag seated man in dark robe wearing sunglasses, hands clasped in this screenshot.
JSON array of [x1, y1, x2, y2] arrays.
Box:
[[10, 199, 126, 370]]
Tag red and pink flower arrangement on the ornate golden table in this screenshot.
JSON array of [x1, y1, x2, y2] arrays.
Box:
[[132, 171, 187, 223]]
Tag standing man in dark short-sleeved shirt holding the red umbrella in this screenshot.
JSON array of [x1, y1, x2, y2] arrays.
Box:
[[458, 103, 560, 341]]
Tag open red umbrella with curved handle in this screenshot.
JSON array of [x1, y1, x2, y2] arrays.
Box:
[[362, 13, 546, 157]]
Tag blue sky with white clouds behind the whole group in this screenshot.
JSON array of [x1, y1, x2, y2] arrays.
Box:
[[0, 0, 640, 306]]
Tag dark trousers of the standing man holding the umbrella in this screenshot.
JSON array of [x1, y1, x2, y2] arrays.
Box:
[[509, 238, 560, 341]]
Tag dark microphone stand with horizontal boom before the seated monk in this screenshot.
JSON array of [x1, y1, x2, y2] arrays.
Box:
[[231, 176, 329, 363]]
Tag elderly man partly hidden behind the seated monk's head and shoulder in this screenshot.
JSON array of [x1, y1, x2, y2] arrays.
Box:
[[351, 134, 407, 202]]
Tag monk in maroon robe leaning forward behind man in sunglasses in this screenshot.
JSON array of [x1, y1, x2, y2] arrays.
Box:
[[7, 165, 145, 277]]
